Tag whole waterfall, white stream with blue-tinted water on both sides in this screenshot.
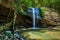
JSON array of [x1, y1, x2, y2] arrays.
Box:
[[28, 8, 40, 29]]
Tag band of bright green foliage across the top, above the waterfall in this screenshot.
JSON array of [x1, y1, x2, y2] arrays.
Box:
[[12, 0, 60, 14]]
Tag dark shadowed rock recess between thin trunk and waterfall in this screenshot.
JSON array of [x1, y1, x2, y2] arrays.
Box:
[[15, 14, 32, 27]]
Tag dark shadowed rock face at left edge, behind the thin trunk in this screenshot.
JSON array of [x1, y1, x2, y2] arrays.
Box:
[[0, 4, 13, 30]]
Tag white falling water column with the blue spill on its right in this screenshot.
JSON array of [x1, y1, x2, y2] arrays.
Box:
[[32, 8, 39, 29]]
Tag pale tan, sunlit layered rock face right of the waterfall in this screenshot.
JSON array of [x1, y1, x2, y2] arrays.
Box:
[[44, 8, 60, 25]]
